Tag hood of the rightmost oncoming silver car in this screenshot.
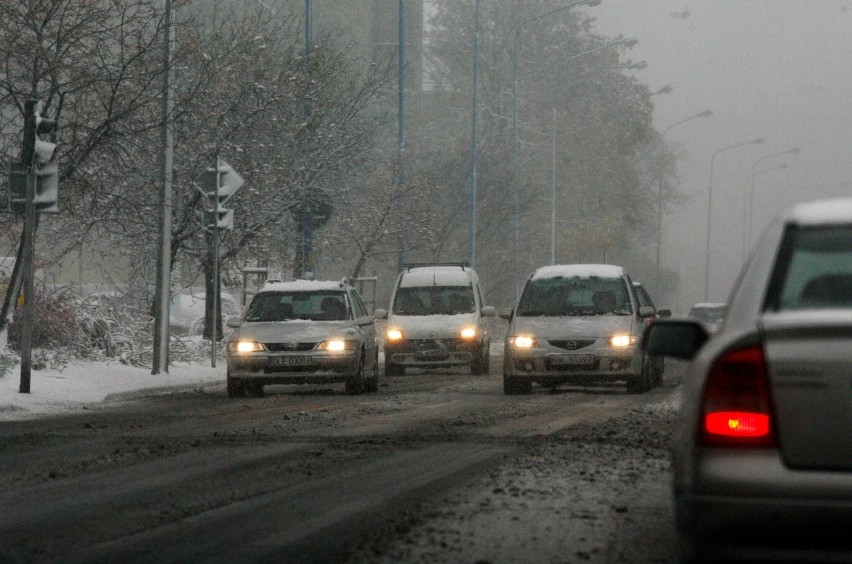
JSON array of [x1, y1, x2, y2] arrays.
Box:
[[512, 315, 639, 339]]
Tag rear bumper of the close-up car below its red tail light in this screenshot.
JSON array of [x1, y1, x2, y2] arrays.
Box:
[[675, 449, 852, 562]]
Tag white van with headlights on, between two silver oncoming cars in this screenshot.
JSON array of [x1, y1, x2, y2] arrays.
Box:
[[375, 263, 496, 376]]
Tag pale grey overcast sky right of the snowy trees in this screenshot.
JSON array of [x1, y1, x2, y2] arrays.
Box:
[[588, 0, 852, 313]]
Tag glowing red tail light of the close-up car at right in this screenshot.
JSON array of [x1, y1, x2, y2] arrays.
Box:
[[698, 346, 775, 446]]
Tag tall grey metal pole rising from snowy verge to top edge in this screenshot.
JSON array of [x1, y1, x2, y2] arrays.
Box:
[[151, 0, 175, 374]]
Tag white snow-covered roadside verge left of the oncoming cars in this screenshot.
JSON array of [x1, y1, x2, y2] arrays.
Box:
[[0, 361, 225, 421]]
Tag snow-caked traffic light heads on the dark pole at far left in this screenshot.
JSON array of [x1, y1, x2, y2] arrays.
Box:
[[9, 100, 59, 213]]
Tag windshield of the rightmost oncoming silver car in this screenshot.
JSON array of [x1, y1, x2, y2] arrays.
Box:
[[518, 276, 632, 317]]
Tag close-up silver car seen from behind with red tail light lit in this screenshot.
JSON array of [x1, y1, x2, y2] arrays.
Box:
[[643, 199, 852, 562]]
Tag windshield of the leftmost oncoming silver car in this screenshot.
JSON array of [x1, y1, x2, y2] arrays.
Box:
[[246, 290, 348, 321]]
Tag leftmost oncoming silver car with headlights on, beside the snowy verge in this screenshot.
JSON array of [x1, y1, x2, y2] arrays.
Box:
[[227, 280, 379, 397]]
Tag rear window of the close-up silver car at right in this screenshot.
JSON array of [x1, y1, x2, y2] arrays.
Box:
[[779, 227, 852, 310]]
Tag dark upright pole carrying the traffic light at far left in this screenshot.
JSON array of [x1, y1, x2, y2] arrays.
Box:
[[18, 100, 38, 394]]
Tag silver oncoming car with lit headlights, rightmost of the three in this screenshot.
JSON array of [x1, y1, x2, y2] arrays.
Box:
[[500, 264, 662, 395]]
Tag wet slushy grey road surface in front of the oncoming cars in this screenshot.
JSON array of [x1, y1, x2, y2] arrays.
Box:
[[0, 359, 679, 562]]
